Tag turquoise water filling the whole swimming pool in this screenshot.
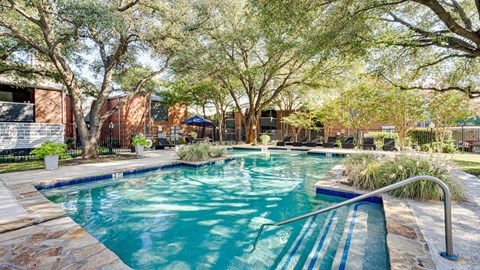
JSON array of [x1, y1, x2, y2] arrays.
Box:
[[42, 151, 388, 269]]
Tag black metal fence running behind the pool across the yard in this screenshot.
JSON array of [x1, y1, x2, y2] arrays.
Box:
[[0, 124, 480, 163]]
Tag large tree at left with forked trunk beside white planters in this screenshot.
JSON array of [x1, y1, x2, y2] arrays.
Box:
[[0, 0, 202, 158]]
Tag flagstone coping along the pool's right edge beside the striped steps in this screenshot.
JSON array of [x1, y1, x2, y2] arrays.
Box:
[[315, 164, 436, 269]]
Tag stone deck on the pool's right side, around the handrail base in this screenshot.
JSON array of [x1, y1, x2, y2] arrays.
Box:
[[317, 165, 480, 270]]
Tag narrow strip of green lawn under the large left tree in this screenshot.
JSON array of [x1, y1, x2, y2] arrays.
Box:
[[0, 155, 136, 174]]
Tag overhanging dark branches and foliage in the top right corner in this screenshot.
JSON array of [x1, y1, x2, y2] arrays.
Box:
[[359, 0, 480, 98]]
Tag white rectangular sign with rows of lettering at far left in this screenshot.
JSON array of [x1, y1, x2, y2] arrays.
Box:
[[0, 122, 64, 150]]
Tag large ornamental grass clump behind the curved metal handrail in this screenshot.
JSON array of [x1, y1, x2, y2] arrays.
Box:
[[344, 154, 463, 200]]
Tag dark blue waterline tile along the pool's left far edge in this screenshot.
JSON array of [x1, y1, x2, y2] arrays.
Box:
[[35, 157, 235, 190]]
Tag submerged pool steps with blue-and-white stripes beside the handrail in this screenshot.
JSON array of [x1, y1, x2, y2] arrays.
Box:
[[276, 202, 369, 270]]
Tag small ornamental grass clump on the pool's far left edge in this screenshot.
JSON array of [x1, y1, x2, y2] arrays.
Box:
[[177, 143, 226, 162]]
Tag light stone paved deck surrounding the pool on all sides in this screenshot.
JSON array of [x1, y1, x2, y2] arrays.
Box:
[[0, 146, 480, 270]]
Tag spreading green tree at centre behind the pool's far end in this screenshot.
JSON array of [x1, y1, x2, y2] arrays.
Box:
[[183, 0, 368, 142]]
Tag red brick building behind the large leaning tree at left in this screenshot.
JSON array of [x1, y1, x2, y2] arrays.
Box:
[[0, 78, 188, 151]]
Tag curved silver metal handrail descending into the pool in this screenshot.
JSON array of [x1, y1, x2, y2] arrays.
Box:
[[250, 175, 458, 261]]
